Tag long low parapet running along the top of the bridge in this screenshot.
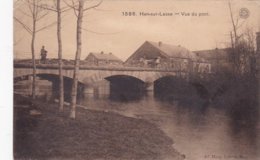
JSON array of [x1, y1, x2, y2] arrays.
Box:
[[14, 59, 213, 74]]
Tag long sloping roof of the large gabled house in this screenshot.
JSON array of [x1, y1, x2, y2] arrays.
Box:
[[147, 41, 197, 59]]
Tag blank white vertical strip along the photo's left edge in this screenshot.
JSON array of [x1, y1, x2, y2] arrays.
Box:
[[0, 0, 13, 160]]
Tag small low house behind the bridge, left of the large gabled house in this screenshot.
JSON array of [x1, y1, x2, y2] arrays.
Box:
[[85, 52, 123, 65]]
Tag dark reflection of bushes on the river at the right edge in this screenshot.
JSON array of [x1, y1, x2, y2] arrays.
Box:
[[227, 98, 259, 155]]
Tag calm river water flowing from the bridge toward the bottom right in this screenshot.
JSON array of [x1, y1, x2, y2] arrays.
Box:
[[77, 96, 260, 160]]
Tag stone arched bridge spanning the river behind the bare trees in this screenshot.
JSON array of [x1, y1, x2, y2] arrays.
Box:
[[14, 63, 212, 101]]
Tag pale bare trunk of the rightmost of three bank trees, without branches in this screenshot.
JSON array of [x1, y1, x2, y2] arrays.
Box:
[[70, 0, 84, 119]]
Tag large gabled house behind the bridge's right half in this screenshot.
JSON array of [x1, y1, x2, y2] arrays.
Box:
[[125, 41, 211, 72]]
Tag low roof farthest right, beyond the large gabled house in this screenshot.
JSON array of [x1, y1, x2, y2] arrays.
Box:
[[193, 48, 230, 60]]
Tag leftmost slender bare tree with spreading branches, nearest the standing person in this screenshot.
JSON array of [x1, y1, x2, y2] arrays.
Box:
[[14, 0, 53, 99]]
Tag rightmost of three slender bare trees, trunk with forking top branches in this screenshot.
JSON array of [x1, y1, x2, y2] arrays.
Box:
[[64, 0, 102, 119]]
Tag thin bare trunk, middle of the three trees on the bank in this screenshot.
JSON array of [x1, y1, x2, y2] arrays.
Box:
[[57, 0, 64, 111]]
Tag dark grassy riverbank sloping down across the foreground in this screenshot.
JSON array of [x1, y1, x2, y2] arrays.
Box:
[[14, 95, 184, 160]]
